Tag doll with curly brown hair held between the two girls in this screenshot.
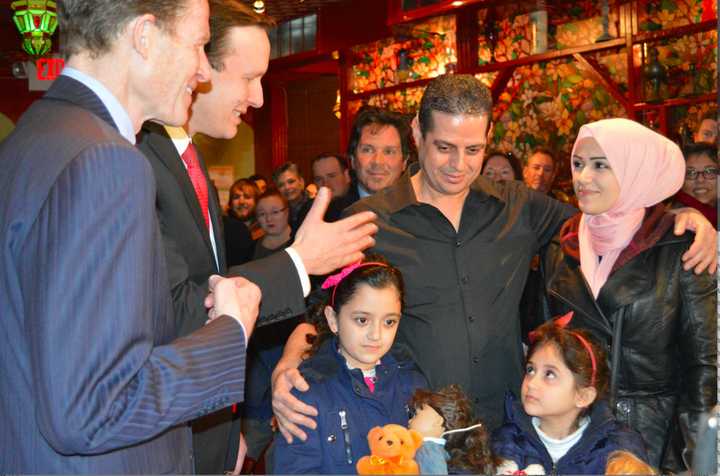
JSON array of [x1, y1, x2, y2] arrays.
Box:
[[409, 385, 497, 474]]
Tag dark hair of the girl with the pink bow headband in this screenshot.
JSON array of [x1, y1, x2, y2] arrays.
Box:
[[306, 254, 405, 356]]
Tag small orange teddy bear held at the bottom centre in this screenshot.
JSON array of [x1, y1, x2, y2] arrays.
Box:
[[355, 425, 423, 474]]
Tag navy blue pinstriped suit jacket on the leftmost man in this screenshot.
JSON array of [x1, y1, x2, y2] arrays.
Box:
[[0, 76, 245, 474]]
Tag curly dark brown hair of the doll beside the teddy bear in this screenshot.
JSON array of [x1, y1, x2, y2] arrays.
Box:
[[410, 385, 499, 474]]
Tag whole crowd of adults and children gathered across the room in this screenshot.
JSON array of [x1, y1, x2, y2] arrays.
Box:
[[0, 0, 718, 474]]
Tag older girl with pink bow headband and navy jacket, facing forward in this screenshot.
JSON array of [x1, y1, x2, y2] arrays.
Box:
[[272, 256, 427, 474]]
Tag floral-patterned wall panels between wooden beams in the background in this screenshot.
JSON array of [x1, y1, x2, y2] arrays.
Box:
[[348, 0, 718, 188]]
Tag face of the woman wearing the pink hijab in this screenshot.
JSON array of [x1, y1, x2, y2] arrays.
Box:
[[571, 137, 620, 215]]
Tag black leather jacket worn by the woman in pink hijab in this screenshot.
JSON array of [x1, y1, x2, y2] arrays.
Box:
[[543, 211, 717, 472]]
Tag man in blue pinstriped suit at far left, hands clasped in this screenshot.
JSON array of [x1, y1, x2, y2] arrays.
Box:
[[0, 0, 372, 474]]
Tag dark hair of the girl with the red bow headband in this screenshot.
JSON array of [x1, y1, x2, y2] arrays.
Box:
[[527, 321, 610, 416]]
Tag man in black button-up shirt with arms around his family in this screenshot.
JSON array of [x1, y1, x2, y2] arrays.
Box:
[[273, 75, 716, 438]]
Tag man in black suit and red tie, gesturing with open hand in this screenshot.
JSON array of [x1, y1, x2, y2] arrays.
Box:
[[138, 0, 380, 474]]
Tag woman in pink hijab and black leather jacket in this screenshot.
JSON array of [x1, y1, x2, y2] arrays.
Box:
[[543, 119, 717, 472]]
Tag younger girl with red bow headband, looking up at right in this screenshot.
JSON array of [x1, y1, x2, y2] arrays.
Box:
[[492, 313, 647, 474]]
